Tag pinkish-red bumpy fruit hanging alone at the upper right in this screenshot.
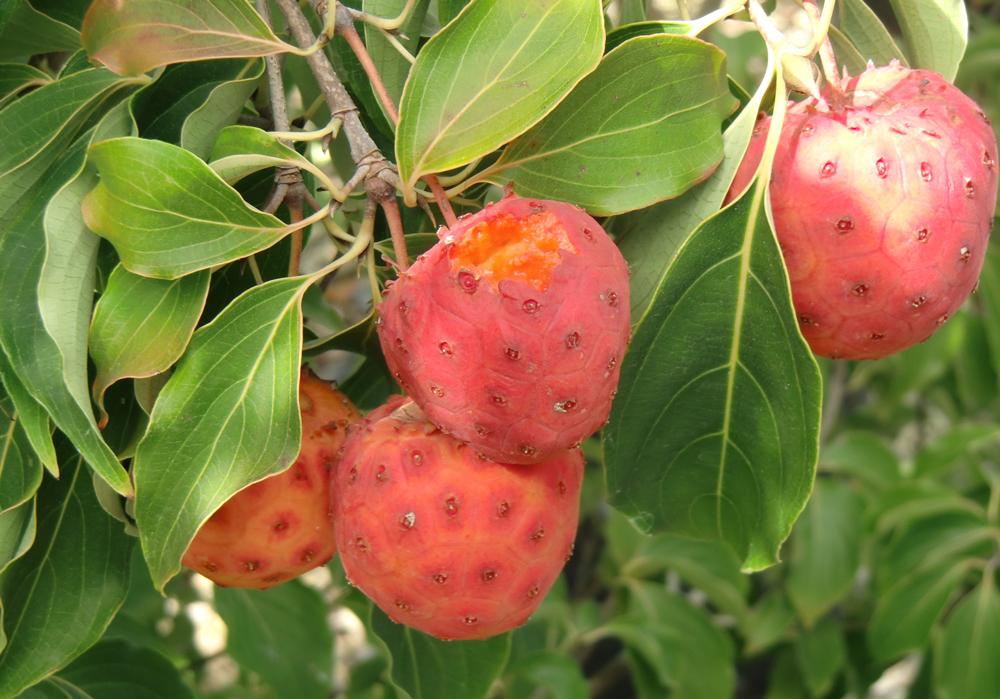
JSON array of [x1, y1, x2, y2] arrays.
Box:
[[729, 64, 997, 359]]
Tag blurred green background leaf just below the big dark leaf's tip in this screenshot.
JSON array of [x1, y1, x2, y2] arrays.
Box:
[[622, 534, 749, 619]]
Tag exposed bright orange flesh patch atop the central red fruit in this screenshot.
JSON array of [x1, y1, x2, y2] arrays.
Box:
[[448, 211, 576, 291]]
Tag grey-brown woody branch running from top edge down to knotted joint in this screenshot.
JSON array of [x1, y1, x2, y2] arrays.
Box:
[[276, 0, 399, 201]]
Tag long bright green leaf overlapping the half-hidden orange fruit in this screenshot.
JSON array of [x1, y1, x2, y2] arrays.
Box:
[[133, 277, 309, 590]]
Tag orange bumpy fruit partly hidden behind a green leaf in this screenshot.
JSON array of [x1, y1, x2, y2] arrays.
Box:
[[183, 371, 361, 589]]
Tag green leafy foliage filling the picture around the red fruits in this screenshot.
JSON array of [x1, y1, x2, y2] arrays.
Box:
[[0, 0, 1000, 699]]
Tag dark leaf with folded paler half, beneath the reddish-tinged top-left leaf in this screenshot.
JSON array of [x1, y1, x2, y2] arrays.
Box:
[[132, 59, 264, 158]]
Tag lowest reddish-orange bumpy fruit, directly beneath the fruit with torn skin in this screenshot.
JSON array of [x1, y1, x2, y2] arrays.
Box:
[[331, 398, 583, 640]]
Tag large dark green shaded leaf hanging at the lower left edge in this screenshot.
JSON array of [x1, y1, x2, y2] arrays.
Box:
[[0, 457, 132, 697]]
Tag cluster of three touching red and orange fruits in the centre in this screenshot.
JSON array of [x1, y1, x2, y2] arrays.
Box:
[[184, 195, 630, 639]]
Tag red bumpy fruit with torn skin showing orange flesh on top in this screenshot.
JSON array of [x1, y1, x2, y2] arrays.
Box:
[[379, 196, 629, 464]]
